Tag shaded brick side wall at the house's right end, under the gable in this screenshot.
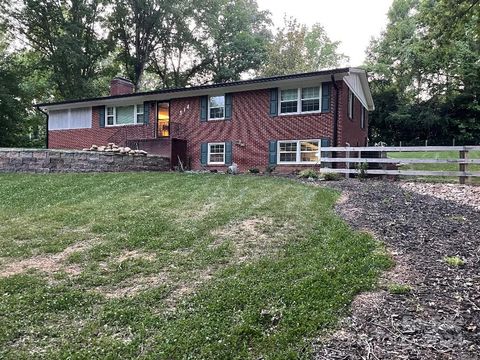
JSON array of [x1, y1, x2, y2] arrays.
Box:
[[338, 81, 368, 146]]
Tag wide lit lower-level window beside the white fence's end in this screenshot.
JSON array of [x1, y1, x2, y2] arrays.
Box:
[[277, 140, 320, 164]]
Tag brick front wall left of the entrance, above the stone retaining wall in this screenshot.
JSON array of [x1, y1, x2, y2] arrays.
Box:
[[48, 106, 156, 149]]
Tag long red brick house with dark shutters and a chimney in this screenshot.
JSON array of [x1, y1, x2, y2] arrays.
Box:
[[37, 68, 374, 171]]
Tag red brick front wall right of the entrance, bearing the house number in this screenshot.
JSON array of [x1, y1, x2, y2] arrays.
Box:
[[170, 89, 334, 171]]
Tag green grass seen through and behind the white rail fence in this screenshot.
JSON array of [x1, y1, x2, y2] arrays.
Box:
[[388, 151, 480, 183]]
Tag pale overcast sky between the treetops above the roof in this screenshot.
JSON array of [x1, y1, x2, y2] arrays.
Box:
[[257, 0, 392, 66]]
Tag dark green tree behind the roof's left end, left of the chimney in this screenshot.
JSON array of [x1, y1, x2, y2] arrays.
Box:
[[10, 0, 111, 99]]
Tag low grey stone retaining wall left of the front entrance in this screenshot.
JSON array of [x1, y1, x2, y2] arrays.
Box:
[[0, 148, 170, 173]]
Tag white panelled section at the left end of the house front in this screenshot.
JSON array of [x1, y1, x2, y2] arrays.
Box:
[[48, 107, 92, 130]]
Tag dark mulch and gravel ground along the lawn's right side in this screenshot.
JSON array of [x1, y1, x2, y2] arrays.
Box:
[[314, 180, 480, 360]]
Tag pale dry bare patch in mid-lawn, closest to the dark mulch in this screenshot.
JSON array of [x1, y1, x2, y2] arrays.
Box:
[[210, 218, 293, 263]]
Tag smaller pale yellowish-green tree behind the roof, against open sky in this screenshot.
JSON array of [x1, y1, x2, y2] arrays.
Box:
[[262, 18, 348, 76]]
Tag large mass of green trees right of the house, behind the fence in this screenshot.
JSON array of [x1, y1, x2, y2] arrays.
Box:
[[367, 0, 480, 144]]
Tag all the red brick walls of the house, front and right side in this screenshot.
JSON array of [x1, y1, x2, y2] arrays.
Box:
[[49, 81, 368, 171]]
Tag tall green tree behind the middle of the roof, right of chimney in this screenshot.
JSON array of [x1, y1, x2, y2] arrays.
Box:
[[149, 0, 271, 87]]
